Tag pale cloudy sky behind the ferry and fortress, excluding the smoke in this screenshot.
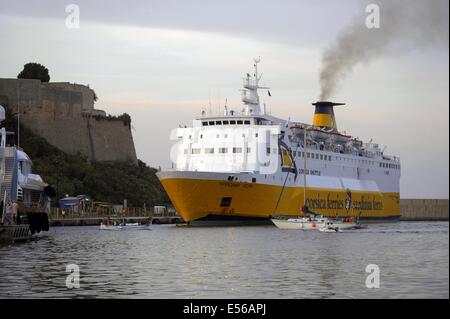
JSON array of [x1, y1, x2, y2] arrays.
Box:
[[0, 0, 449, 198]]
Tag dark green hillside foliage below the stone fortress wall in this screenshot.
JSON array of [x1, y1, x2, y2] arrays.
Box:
[[3, 108, 170, 207]]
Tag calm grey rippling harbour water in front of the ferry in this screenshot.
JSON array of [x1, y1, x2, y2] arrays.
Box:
[[0, 222, 449, 298]]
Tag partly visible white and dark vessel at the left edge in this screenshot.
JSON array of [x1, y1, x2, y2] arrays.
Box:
[[0, 105, 53, 243]]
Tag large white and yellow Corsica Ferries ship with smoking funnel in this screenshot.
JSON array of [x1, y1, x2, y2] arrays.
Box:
[[157, 60, 400, 222]]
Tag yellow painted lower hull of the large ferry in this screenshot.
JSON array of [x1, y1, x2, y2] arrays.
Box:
[[161, 179, 400, 221]]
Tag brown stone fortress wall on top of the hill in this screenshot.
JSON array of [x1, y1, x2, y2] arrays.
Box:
[[0, 79, 137, 163]]
